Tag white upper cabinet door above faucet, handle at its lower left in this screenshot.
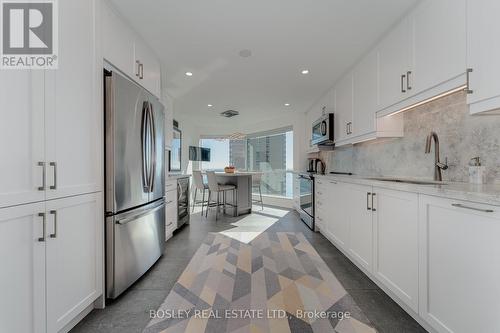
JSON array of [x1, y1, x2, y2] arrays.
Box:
[[408, 0, 466, 94]]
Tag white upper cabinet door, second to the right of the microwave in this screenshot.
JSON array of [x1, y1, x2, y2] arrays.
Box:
[[353, 52, 378, 136]]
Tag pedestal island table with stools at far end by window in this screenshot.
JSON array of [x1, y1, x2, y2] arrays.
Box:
[[215, 172, 262, 216]]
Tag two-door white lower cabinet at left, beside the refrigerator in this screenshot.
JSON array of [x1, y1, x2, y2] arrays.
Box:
[[0, 193, 103, 333]]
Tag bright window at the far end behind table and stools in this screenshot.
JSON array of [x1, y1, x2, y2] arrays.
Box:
[[200, 128, 293, 198]]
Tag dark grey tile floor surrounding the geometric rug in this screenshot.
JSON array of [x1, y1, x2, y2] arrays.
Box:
[[71, 208, 426, 333]]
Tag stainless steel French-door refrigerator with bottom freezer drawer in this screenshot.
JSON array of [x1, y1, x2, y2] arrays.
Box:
[[104, 70, 165, 298]]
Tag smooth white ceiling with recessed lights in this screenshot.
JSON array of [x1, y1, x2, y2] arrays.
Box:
[[112, 0, 416, 126]]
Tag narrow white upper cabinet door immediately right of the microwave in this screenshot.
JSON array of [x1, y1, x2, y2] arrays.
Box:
[[334, 73, 353, 145]]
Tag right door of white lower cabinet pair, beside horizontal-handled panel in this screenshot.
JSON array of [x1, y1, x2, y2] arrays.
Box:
[[373, 187, 418, 312]]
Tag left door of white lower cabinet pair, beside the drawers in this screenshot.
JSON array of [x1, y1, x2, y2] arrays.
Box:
[[343, 184, 373, 272]]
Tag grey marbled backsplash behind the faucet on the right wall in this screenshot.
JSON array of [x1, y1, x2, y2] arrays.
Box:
[[320, 92, 500, 183]]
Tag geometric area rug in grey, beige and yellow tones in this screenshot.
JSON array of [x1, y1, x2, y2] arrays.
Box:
[[143, 232, 376, 333]]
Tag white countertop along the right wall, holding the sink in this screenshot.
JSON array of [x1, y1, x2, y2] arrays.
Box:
[[314, 174, 500, 206]]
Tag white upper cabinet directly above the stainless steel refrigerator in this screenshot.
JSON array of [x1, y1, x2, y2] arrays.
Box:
[[102, 2, 161, 98]]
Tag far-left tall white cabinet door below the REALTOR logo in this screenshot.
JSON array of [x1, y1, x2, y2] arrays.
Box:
[[0, 70, 47, 207]]
